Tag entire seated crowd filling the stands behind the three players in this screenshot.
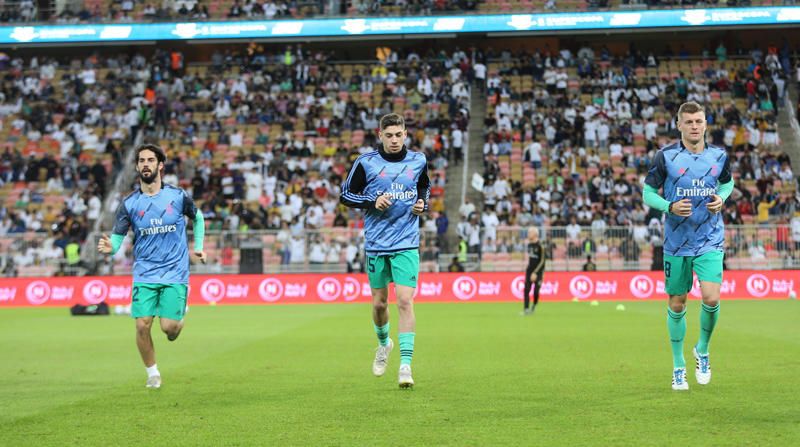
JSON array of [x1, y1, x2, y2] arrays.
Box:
[[0, 38, 800, 274]]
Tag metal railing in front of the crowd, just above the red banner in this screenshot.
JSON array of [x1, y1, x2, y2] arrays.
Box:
[[0, 225, 800, 276]]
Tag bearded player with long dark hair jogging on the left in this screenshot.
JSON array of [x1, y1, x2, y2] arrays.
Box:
[[97, 144, 206, 388]]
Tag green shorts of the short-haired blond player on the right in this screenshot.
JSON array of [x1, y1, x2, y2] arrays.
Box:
[[664, 250, 725, 295]]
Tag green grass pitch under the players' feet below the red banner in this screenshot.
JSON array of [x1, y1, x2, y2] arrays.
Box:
[[0, 301, 800, 446]]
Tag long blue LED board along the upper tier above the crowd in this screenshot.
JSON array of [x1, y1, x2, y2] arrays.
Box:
[[0, 6, 800, 46]]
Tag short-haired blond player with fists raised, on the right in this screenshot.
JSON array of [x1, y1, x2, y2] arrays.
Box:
[[643, 101, 733, 390]]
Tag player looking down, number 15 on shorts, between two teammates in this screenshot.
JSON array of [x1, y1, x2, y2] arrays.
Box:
[[340, 113, 430, 388]]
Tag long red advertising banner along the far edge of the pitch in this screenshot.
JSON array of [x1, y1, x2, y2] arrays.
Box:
[[0, 270, 800, 307]]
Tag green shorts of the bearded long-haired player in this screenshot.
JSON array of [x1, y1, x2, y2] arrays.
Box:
[[131, 282, 187, 320]]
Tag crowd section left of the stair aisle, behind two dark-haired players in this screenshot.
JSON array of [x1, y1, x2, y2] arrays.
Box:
[[0, 45, 470, 276]]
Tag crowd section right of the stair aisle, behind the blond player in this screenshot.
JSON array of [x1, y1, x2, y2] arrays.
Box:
[[468, 44, 800, 270]]
